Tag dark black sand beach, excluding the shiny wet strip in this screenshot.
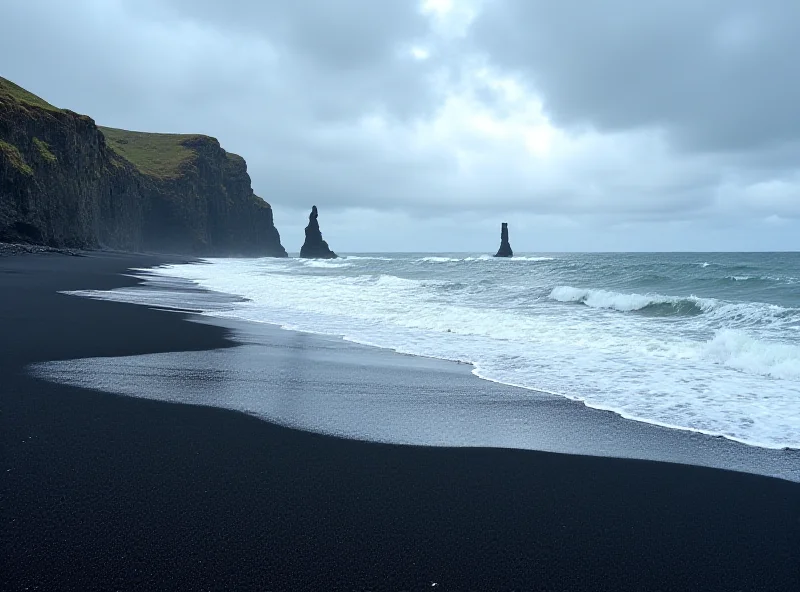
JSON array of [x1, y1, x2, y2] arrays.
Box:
[[0, 253, 800, 590]]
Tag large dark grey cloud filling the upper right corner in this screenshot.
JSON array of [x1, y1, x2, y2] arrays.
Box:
[[472, 0, 800, 150]]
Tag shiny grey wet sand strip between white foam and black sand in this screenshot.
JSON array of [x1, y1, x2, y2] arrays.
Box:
[[30, 314, 800, 482]]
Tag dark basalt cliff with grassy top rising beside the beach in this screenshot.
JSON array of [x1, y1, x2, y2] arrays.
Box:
[[0, 78, 286, 257]]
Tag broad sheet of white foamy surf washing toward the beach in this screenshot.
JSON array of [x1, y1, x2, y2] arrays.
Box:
[[59, 258, 800, 448]]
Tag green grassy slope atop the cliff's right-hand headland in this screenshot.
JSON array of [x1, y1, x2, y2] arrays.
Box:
[[100, 127, 206, 179]]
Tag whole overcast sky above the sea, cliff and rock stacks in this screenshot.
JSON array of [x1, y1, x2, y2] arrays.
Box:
[[0, 0, 800, 252]]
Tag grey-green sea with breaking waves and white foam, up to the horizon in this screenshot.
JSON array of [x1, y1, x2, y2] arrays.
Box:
[[72, 253, 800, 448]]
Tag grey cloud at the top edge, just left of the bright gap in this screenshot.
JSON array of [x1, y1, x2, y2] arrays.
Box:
[[131, 0, 444, 120]]
